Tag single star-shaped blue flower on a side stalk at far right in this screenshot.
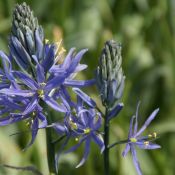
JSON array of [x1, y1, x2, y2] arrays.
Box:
[[122, 103, 160, 175]]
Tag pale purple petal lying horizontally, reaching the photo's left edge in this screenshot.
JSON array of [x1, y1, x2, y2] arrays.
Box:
[[0, 89, 35, 97]]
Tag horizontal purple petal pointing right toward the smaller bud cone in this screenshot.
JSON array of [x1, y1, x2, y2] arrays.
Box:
[[64, 79, 95, 87]]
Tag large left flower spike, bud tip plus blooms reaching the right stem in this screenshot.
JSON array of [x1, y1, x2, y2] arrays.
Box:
[[0, 3, 104, 166]]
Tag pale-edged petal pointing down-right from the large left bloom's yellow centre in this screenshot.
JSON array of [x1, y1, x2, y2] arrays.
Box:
[[43, 96, 67, 112]]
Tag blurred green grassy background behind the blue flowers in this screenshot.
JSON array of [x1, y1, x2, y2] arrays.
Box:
[[0, 0, 175, 175]]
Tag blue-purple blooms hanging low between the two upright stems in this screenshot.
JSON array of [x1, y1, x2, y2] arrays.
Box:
[[54, 88, 105, 168]]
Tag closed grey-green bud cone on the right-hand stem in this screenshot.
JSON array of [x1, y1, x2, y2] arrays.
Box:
[[95, 40, 125, 108]]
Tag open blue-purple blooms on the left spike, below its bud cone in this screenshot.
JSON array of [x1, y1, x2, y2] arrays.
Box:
[[0, 37, 94, 145]]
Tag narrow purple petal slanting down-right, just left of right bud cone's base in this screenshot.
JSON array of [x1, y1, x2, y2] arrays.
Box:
[[72, 88, 96, 107]]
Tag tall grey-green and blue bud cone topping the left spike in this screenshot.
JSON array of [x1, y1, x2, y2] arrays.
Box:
[[9, 2, 44, 71]]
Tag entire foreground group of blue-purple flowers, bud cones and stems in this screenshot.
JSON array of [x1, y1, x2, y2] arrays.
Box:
[[0, 3, 160, 175]]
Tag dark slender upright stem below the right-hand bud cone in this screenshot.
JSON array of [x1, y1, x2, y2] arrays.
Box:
[[104, 107, 109, 175]]
